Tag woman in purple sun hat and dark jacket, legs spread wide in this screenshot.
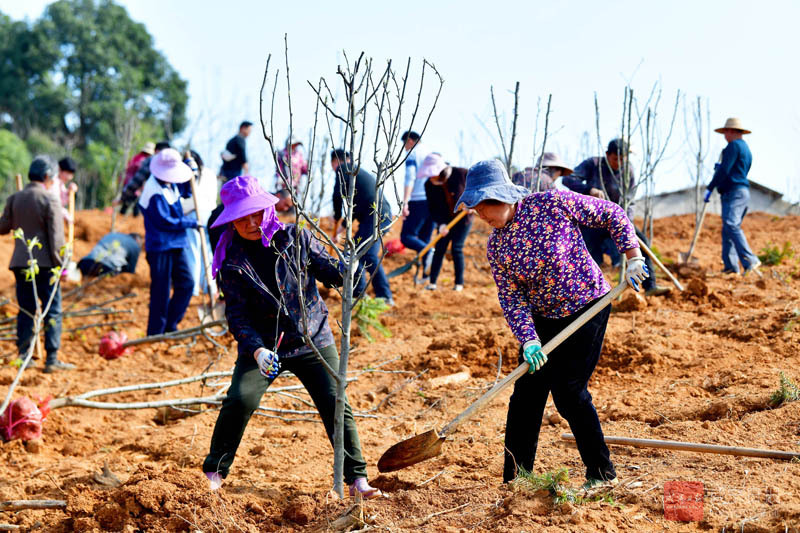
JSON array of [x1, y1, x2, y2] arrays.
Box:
[[203, 176, 381, 498]]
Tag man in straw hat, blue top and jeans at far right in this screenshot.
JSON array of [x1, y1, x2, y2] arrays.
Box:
[[703, 118, 761, 274]]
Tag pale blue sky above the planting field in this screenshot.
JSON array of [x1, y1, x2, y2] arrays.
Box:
[[0, 0, 800, 199]]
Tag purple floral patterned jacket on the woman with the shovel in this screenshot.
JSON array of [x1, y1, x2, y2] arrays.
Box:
[[486, 189, 639, 344]]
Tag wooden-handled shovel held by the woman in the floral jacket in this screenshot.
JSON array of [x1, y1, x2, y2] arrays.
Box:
[[378, 283, 628, 472]]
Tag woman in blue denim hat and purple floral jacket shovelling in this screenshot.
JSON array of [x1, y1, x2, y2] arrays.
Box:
[[457, 161, 648, 490]]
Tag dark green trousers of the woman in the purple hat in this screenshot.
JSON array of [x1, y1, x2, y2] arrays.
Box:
[[203, 344, 367, 484]]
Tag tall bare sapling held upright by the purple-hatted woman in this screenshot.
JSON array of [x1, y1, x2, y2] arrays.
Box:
[[260, 36, 444, 496]]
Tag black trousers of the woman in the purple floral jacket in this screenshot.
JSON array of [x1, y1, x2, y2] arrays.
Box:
[[503, 300, 616, 482]]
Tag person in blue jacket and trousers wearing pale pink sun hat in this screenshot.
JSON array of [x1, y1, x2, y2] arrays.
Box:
[[139, 148, 197, 335]]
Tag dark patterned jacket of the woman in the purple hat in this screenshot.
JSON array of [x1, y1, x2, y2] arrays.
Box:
[[219, 224, 343, 364]]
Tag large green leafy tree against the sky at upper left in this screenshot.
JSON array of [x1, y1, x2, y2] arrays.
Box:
[[0, 0, 188, 207]]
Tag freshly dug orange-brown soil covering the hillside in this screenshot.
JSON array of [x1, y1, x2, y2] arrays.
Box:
[[0, 211, 800, 532]]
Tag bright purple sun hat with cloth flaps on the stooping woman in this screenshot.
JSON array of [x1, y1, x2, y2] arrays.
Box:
[[211, 176, 284, 277]]
